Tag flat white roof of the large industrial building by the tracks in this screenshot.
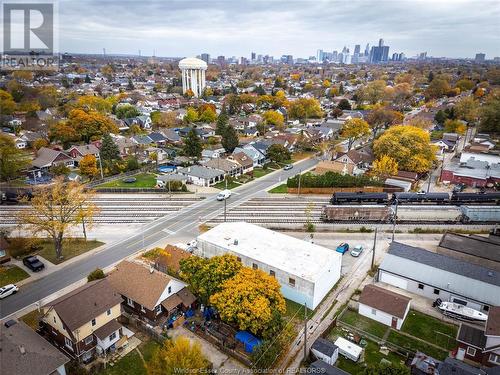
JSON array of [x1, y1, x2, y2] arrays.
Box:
[[198, 222, 342, 282]]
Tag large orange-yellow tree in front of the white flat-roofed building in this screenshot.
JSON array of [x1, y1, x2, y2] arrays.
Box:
[[210, 267, 286, 335]]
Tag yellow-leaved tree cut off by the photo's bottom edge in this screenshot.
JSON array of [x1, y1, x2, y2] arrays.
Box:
[[147, 336, 212, 375]]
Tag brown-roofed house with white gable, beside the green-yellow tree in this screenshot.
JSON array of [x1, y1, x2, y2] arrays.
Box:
[[107, 261, 195, 325]]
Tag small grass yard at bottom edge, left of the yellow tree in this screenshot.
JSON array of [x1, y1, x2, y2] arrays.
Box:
[[99, 340, 159, 375]]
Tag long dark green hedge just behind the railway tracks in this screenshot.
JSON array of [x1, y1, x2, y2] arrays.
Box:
[[286, 172, 384, 188]]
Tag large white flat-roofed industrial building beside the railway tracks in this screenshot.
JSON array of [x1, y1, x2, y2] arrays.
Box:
[[198, 222, 342, 309]]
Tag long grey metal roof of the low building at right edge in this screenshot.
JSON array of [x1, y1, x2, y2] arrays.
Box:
[[380, 242, 500, 306]]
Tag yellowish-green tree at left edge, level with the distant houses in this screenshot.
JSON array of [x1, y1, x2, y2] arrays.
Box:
[[0, 133, 30, 181]]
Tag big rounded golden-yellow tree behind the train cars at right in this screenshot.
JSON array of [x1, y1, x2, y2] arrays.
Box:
[[373, 125, 436, 173]]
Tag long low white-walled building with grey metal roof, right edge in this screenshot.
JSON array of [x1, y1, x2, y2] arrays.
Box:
[[378, 242, 500, 312]]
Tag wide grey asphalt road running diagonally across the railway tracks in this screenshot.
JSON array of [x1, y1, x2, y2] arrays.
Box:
[[0, 159, 317, 318]]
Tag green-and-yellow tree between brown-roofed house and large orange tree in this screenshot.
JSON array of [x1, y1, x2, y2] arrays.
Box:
[[180, 254, 241, 303]]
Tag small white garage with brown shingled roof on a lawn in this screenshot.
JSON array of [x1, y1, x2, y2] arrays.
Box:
[[358, 284, 411, 330]]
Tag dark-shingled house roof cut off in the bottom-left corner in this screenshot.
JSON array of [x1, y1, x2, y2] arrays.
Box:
[[0, 320, 69, 375]]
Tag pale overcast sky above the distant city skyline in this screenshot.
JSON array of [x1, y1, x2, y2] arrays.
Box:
[[59, 0, 500, 58]]
